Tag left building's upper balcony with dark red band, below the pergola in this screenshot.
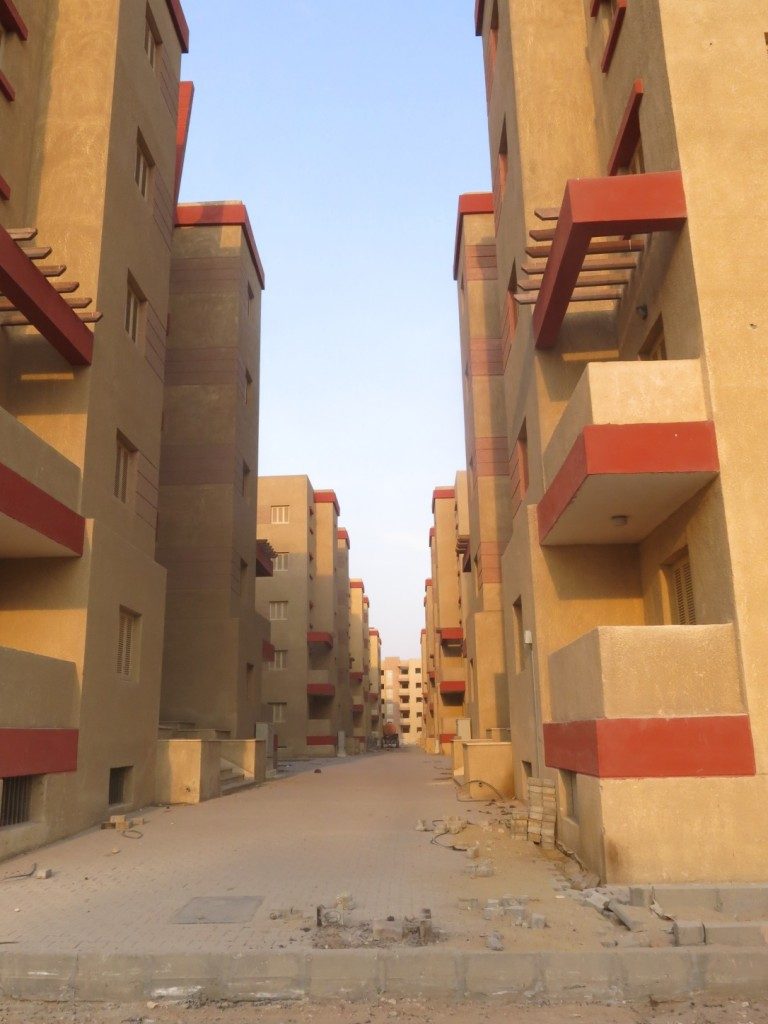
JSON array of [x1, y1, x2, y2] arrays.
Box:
[[0, 409, 85, 558]]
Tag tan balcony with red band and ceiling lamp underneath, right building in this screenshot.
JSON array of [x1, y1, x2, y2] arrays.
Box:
[[538, 359, 719, 545]]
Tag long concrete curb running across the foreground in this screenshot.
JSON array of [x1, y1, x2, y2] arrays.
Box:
[[0, 946, 768, 1004]]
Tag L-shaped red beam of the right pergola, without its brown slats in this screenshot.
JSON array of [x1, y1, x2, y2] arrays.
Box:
[[534, 171, 686, 348]]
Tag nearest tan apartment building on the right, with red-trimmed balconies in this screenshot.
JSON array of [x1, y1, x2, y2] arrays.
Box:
[[462, 0, 768, 882]]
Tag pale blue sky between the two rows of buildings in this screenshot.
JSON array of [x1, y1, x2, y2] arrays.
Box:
[[181, 0, 488, 657]]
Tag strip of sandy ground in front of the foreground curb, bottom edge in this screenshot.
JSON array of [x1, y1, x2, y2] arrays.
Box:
[[0, 998, 768, 1024]]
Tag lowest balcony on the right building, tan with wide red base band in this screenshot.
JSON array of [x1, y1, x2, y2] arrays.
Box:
[[544, 624, 755, 778]]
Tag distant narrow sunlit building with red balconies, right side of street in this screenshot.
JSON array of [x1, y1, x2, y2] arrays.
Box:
[[422, 472, 469, 754]]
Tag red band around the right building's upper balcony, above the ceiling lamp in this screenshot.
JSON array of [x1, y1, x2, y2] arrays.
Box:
[[537, 420, 720, 543]]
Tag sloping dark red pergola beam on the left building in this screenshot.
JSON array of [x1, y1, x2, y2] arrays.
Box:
[[0, 227, 93, 367]]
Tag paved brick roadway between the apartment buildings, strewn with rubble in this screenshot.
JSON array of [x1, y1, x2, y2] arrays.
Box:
[[0, 750, 614, 953]]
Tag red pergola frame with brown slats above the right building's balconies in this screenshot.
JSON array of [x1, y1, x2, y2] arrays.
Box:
[[515, 171, 687, 348]]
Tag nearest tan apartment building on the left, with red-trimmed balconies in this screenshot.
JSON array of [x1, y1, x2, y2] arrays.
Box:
[[0, 0, 187, 855]]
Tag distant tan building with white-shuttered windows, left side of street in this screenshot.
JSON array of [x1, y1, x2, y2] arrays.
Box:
[[256, 476, 354, 758]]
